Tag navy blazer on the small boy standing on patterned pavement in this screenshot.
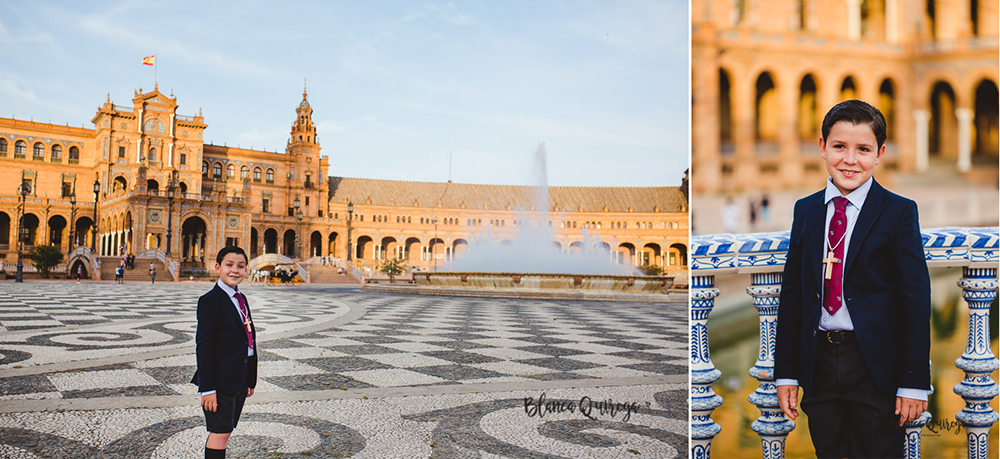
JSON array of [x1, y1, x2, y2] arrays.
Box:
[[191, 284, 260, 395]]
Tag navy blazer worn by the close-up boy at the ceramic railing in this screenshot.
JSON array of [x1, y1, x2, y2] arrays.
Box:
[[774, 182, 931, 395]]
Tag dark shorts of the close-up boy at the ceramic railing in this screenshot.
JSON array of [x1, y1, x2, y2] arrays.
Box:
[[802, 334, 906, 459]]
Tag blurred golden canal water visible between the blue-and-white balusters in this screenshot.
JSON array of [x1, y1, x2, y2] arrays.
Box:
[[709, 268, 1000, 459]]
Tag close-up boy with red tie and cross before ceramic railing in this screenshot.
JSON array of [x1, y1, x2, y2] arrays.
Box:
[[774, 100, 930, 458]]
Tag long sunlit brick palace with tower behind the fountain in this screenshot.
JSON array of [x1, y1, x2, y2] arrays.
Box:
[[0, 88, 688, 274]]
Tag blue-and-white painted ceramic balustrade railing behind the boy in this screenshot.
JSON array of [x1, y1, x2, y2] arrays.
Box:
[[690, 228, 1000, 459]]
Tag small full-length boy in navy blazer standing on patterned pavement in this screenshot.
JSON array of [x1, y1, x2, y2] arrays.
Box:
[[191, 246, 258, 459]]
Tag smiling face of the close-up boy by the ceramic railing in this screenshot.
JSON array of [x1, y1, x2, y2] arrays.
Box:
[[819, 121, 885, 196]]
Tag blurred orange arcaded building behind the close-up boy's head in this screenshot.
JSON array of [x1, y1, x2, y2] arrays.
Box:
[[691, 0, 1000, 193]]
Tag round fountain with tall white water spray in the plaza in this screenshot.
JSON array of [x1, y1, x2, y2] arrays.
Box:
[[376, 144, 680, 301]]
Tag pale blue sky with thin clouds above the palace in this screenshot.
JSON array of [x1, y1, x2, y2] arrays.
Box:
[[0, 0, 691, 186]]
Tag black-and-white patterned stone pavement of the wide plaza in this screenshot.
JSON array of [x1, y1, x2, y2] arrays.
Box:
[[0, 282, 688, 458]]
